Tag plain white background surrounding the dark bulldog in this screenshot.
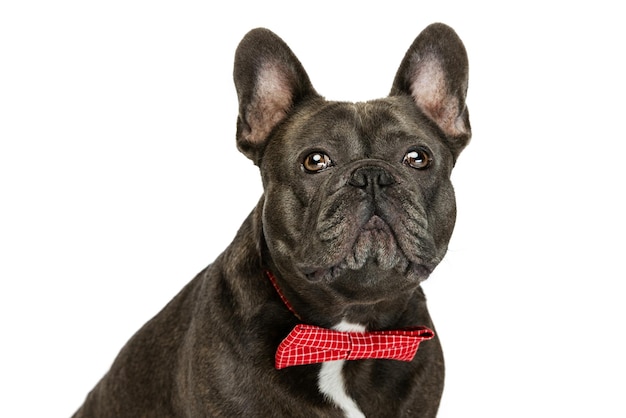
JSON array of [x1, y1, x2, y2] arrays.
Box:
[[0, 0, 626, 418]]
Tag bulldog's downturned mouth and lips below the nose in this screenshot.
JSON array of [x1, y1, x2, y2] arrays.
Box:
[[304, 215, 432, 281]]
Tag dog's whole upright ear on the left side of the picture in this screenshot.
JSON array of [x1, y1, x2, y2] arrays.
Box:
[[233, 28, 317, 164]]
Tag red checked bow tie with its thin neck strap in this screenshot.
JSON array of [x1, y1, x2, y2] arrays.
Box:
[[267, 271, 435, 369]]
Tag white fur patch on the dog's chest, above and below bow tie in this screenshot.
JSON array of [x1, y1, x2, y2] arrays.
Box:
[[317, 321, 365, 418]]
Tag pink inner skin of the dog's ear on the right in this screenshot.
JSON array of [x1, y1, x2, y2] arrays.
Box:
[[411, 58, 467, 136]]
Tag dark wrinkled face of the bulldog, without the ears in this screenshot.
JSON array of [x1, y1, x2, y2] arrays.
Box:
[[261, 97, 455, 300]]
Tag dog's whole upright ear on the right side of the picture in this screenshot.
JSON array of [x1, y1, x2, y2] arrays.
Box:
[[390, 23, 471, 160]]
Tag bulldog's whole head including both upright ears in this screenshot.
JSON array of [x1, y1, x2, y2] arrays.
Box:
[[235, 24, 470, 310]]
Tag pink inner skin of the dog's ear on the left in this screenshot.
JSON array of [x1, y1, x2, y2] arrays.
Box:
[[245, 62, 292, 143]]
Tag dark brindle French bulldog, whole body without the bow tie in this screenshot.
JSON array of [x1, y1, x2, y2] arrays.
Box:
[[74, 24, 471, 418]]
